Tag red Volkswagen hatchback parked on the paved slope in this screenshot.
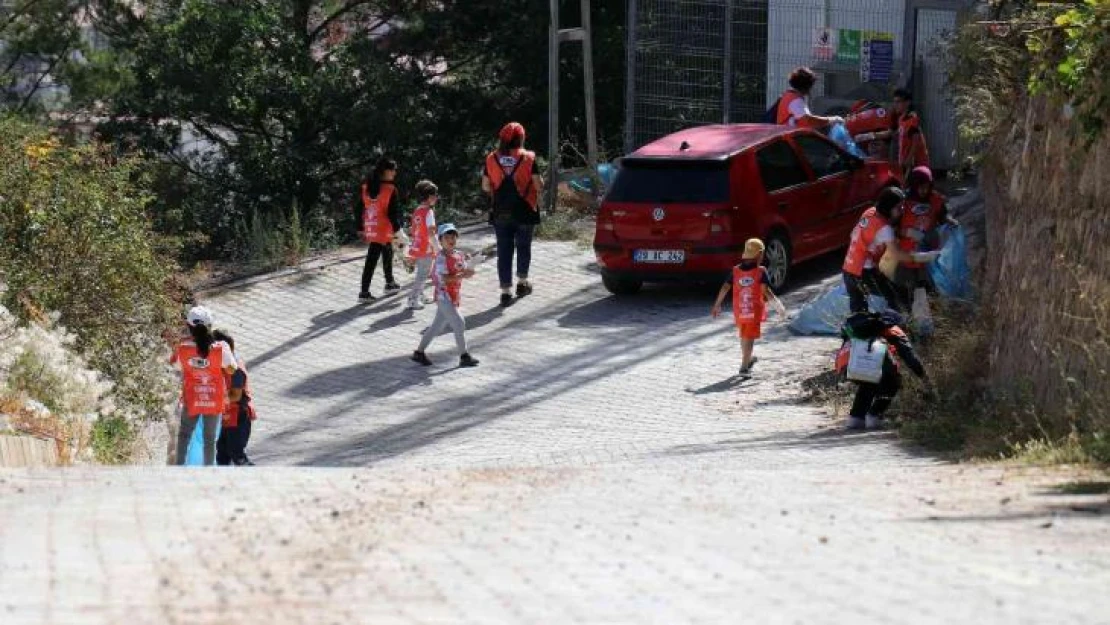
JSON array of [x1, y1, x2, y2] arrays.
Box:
[[594, 124, 899, 294]]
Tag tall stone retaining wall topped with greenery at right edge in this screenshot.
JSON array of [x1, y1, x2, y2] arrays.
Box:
[[952, 0, 1110, 461]]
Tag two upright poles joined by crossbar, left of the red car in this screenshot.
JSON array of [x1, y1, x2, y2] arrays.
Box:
[[547, 0, 597, 211]]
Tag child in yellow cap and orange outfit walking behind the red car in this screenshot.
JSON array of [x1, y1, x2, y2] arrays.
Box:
[[710, 239, 786, 375]]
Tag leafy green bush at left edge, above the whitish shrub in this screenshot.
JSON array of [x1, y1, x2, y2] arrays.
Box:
[[0, 119, 180, 428]]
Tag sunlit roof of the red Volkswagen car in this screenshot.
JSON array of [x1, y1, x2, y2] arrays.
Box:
[[629, 123, 798, 160]]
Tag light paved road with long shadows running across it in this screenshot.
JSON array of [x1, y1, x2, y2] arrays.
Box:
[[0, 241, 1110, 624]]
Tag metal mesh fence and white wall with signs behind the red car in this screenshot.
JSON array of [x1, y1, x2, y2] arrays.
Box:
[[625, 0, 961, 160]]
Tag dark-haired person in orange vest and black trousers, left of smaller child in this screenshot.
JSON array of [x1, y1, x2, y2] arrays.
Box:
[[355, 158, 402, 302]]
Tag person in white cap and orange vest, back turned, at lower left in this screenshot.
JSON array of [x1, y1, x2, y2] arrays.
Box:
[[170, 306, 238, 465]]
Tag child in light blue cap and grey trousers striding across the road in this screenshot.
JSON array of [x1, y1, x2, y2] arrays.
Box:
[[412, 223, 478, 366]]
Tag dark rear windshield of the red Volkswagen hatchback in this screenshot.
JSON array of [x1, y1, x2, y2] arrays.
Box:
[[605, 160, 728, 204]]
